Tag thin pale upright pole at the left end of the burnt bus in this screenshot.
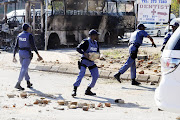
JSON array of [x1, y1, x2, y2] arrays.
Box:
[[45, 0, 48, 50]]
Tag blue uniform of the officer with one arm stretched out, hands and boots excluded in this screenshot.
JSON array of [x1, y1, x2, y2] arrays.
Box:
[[119, 29, 148, 80]]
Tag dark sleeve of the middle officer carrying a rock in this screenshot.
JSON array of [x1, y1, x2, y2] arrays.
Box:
[[76, 40, 89, 54]]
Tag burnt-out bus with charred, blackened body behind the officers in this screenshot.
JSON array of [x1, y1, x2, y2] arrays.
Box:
[[46, 0, 135, 49]]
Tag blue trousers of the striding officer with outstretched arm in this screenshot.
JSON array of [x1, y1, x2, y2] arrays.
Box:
[[119, 45, 138, 79]]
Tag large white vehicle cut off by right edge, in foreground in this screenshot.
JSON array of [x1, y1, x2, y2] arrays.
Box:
[[155, 27, 180, 113]]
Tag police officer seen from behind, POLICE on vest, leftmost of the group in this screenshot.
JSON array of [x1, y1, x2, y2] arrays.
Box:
[[13, 24, 42, 90]]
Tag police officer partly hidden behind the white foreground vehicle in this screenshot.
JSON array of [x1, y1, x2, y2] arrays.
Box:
[[161, 22, 179, 52]]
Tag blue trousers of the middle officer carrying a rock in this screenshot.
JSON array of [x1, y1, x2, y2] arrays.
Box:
[[74, 59, 99, 88]]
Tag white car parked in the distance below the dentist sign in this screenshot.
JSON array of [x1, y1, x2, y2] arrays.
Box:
[[141, 22, 168, 37]]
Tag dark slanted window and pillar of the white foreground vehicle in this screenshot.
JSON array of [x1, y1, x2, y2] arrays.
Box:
[[165, 27, 180, 50]]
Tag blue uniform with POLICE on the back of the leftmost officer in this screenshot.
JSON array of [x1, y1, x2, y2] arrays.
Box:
[[14, 31, 38, 87]]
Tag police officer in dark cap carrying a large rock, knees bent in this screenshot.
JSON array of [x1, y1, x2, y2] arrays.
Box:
[[72, 29, 100, 97]]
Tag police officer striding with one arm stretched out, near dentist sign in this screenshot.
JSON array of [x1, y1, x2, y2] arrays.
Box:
[[114, 24, 156, 85]]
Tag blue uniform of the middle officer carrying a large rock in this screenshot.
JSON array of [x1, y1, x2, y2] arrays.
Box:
[[74, 38, 99, 88]]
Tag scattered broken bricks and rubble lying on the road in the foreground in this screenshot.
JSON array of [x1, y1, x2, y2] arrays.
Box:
[[3, 92, 125, 111]]
